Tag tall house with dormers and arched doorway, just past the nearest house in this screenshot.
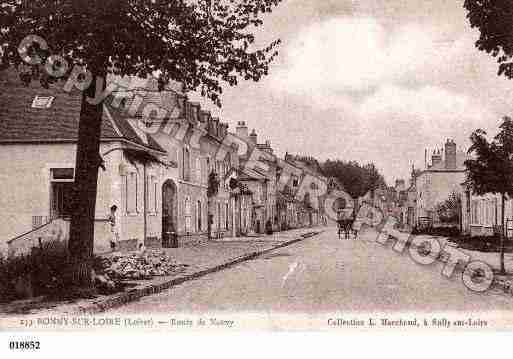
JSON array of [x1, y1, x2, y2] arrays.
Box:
[[122, 81, 237, 245]]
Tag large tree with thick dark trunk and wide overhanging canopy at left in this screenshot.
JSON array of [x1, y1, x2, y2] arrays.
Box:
[[0, 0, 281, 286]]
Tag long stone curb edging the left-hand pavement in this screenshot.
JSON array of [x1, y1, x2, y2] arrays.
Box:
[[72, 230, 324, 315]]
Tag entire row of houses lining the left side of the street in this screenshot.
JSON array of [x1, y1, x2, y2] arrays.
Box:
[[0, 69, 334, 252]]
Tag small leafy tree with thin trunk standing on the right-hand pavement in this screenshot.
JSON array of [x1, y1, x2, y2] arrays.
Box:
[[465, 117, 513, 274]]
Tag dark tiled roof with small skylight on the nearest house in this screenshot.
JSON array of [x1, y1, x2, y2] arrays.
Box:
[[0, 69, 165, 152]]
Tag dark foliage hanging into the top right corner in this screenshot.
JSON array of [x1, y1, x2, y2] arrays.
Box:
[[463, 0, 513, 79]]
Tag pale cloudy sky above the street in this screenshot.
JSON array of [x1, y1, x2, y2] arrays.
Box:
[[187, 0, 513, 184]]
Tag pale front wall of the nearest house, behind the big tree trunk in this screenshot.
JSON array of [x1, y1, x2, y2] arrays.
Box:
[[0, 143, 120, 250]]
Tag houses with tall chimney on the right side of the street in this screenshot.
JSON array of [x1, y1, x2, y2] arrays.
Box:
[[390, 139, 513, 236]]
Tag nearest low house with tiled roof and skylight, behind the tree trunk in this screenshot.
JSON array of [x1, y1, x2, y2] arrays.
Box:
[[0, 70, 168, 252]]
